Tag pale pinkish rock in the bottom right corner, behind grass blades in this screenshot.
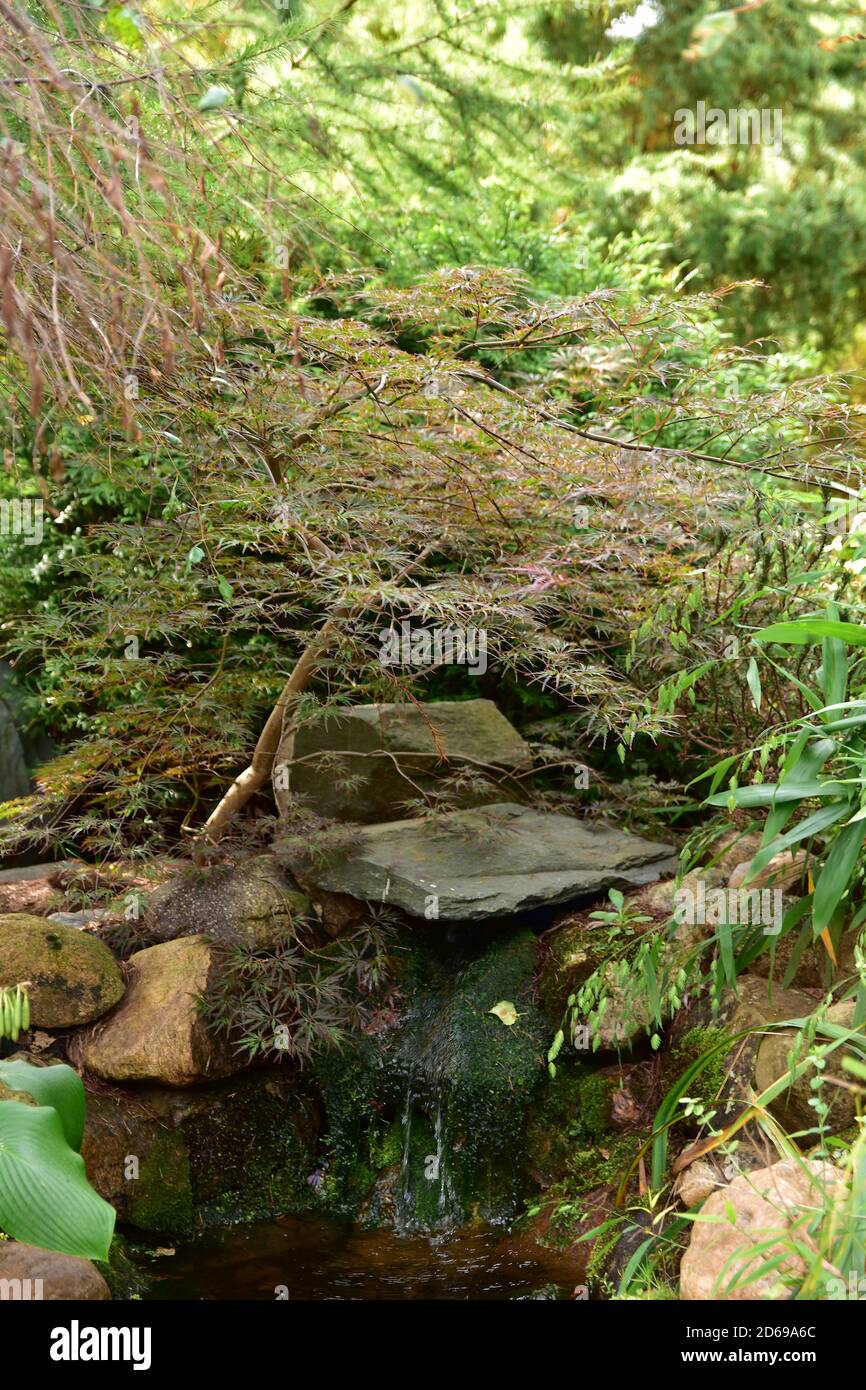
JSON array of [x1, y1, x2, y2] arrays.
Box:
[[680, 1158, 845, 1301]]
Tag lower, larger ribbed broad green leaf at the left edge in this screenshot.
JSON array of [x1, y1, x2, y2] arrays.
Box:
[[0, 1101, 114, 1259]]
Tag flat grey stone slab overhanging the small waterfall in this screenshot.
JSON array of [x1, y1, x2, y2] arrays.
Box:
[[282, 802, 677, 922]]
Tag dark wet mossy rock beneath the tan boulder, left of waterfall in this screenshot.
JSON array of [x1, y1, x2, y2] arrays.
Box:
[[82, 1072, 318, 1232]]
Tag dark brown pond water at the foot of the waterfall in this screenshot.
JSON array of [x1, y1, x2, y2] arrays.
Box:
[[145, 1216, 589, 1300]]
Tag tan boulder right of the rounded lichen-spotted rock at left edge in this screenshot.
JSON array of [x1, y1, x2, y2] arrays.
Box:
[[71, 937, 237, 1086]]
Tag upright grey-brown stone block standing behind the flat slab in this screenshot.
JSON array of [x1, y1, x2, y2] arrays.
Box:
[[280, 699, 531, 823]]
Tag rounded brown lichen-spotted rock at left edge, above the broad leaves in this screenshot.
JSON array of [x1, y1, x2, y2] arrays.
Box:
[[0, 913, 124, 1029]]
